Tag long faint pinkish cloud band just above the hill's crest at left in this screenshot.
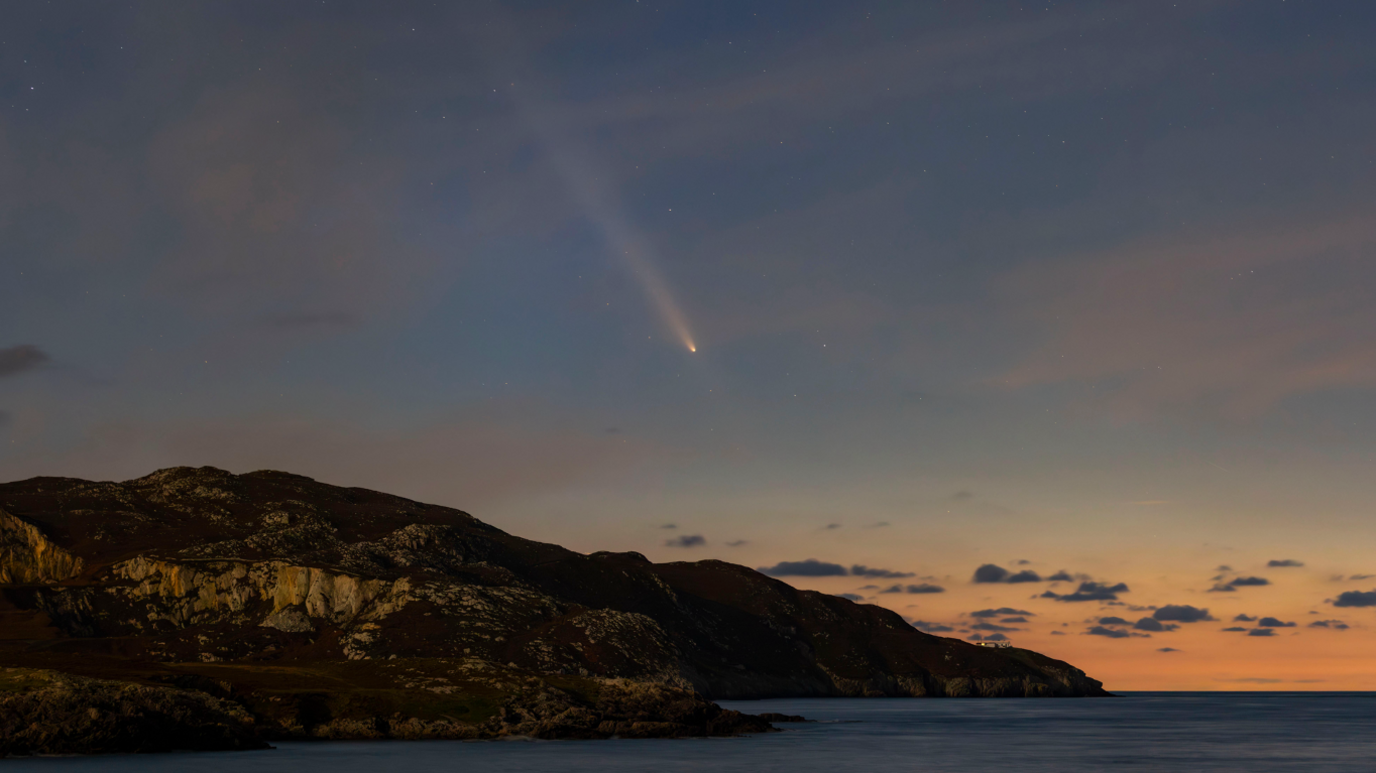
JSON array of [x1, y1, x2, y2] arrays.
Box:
[[6, 399, 670, 516]]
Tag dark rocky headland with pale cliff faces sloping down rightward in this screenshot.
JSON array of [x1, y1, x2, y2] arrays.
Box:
[[0, 468, 1106, 753]]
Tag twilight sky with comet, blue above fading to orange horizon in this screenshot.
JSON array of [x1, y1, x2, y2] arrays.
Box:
[[0, 0, 1376, 689]]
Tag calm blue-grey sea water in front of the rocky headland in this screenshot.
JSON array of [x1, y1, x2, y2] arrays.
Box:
[[0, 693, 1376, 773]]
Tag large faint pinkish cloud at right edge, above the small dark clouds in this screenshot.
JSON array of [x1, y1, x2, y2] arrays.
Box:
[[998, 212, 1376, 421]]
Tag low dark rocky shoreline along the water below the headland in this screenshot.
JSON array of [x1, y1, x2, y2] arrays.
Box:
[[0, 660, 802, 756]]
